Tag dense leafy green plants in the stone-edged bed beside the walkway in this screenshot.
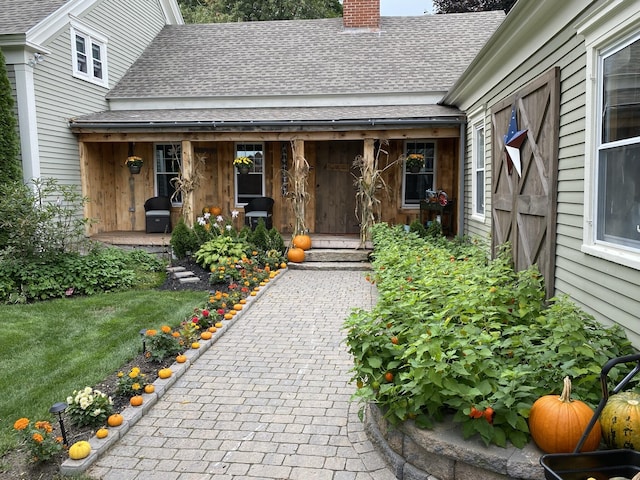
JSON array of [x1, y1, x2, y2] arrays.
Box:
[[345, 224, 632, 447]]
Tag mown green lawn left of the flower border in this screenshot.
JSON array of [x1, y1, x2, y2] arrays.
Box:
[[0, 290, 207, 455]]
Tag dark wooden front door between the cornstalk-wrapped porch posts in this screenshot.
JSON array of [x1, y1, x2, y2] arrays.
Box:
[[315, 141, 363, 234]]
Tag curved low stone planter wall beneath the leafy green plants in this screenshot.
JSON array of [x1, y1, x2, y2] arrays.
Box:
[[366, 405, 545, 480]]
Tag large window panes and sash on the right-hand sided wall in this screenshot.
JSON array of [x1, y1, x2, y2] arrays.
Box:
[[595, 34, 640, 250]]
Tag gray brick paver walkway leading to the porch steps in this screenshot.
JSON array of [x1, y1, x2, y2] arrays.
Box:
[[87, 270, 395, 480]]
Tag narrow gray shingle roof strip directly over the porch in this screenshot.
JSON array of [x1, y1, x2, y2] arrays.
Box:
[[67, 105, 463, 128]]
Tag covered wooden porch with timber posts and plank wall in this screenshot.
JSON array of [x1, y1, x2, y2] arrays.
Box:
[[72, 106, 465, 238]]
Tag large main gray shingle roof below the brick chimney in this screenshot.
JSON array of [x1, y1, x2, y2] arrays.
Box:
[[109, 11, 504, 99]]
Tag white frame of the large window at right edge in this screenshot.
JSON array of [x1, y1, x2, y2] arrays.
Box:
[[576, 0, 640, 270]]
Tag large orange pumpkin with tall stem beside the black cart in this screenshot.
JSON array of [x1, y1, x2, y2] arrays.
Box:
[[529, 377, 602, 453]]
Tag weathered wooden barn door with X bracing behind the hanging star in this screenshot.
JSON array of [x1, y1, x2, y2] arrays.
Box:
[[491, 68, 560, 297]]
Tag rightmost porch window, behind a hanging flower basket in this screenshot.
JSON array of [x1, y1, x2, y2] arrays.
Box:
[[402, 140, 436, 207]]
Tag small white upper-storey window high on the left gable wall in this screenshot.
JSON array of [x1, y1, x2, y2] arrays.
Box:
[[71, 22, 108, 87]]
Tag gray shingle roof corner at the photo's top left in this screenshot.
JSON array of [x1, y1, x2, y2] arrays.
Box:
[[0, 0, 67, 35]]
